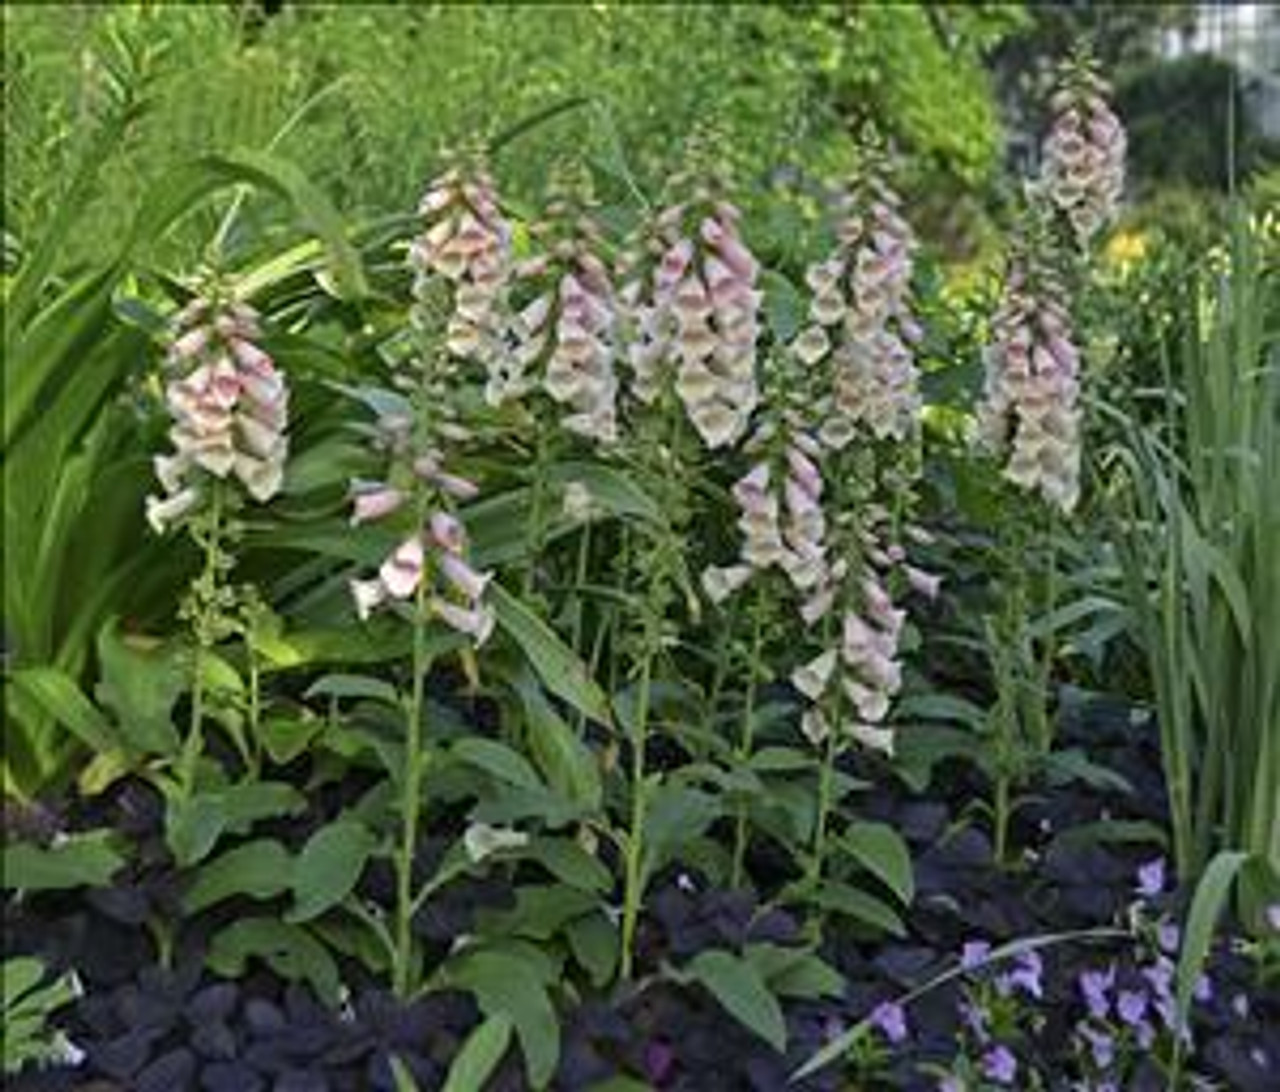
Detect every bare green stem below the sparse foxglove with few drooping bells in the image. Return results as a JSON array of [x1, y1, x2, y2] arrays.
[[392, 574, 429, 999]]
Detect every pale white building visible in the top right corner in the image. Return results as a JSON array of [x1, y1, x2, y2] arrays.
[[1162, 0, 1280, 141]]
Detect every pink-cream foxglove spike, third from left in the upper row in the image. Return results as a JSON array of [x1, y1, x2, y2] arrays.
[[507, 172, 618, 443]]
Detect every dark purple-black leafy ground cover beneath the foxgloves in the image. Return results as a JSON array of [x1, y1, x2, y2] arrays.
[[4, 705, 1280, 1092]]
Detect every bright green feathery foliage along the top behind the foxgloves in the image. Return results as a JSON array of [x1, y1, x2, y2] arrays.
[[4, 4, 1023, 270]]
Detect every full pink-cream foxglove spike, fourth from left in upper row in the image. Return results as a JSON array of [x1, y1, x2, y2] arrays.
[[625, 191, 763, 448]]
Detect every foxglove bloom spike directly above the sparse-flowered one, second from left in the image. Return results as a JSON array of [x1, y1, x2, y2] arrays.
[[410, 160, 512, 403]]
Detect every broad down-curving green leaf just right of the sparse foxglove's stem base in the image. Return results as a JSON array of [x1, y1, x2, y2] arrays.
[[449, 949, 561, 1088]]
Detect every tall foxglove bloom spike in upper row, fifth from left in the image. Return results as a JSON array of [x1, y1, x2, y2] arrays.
[[791, 172, 923, 451]]
